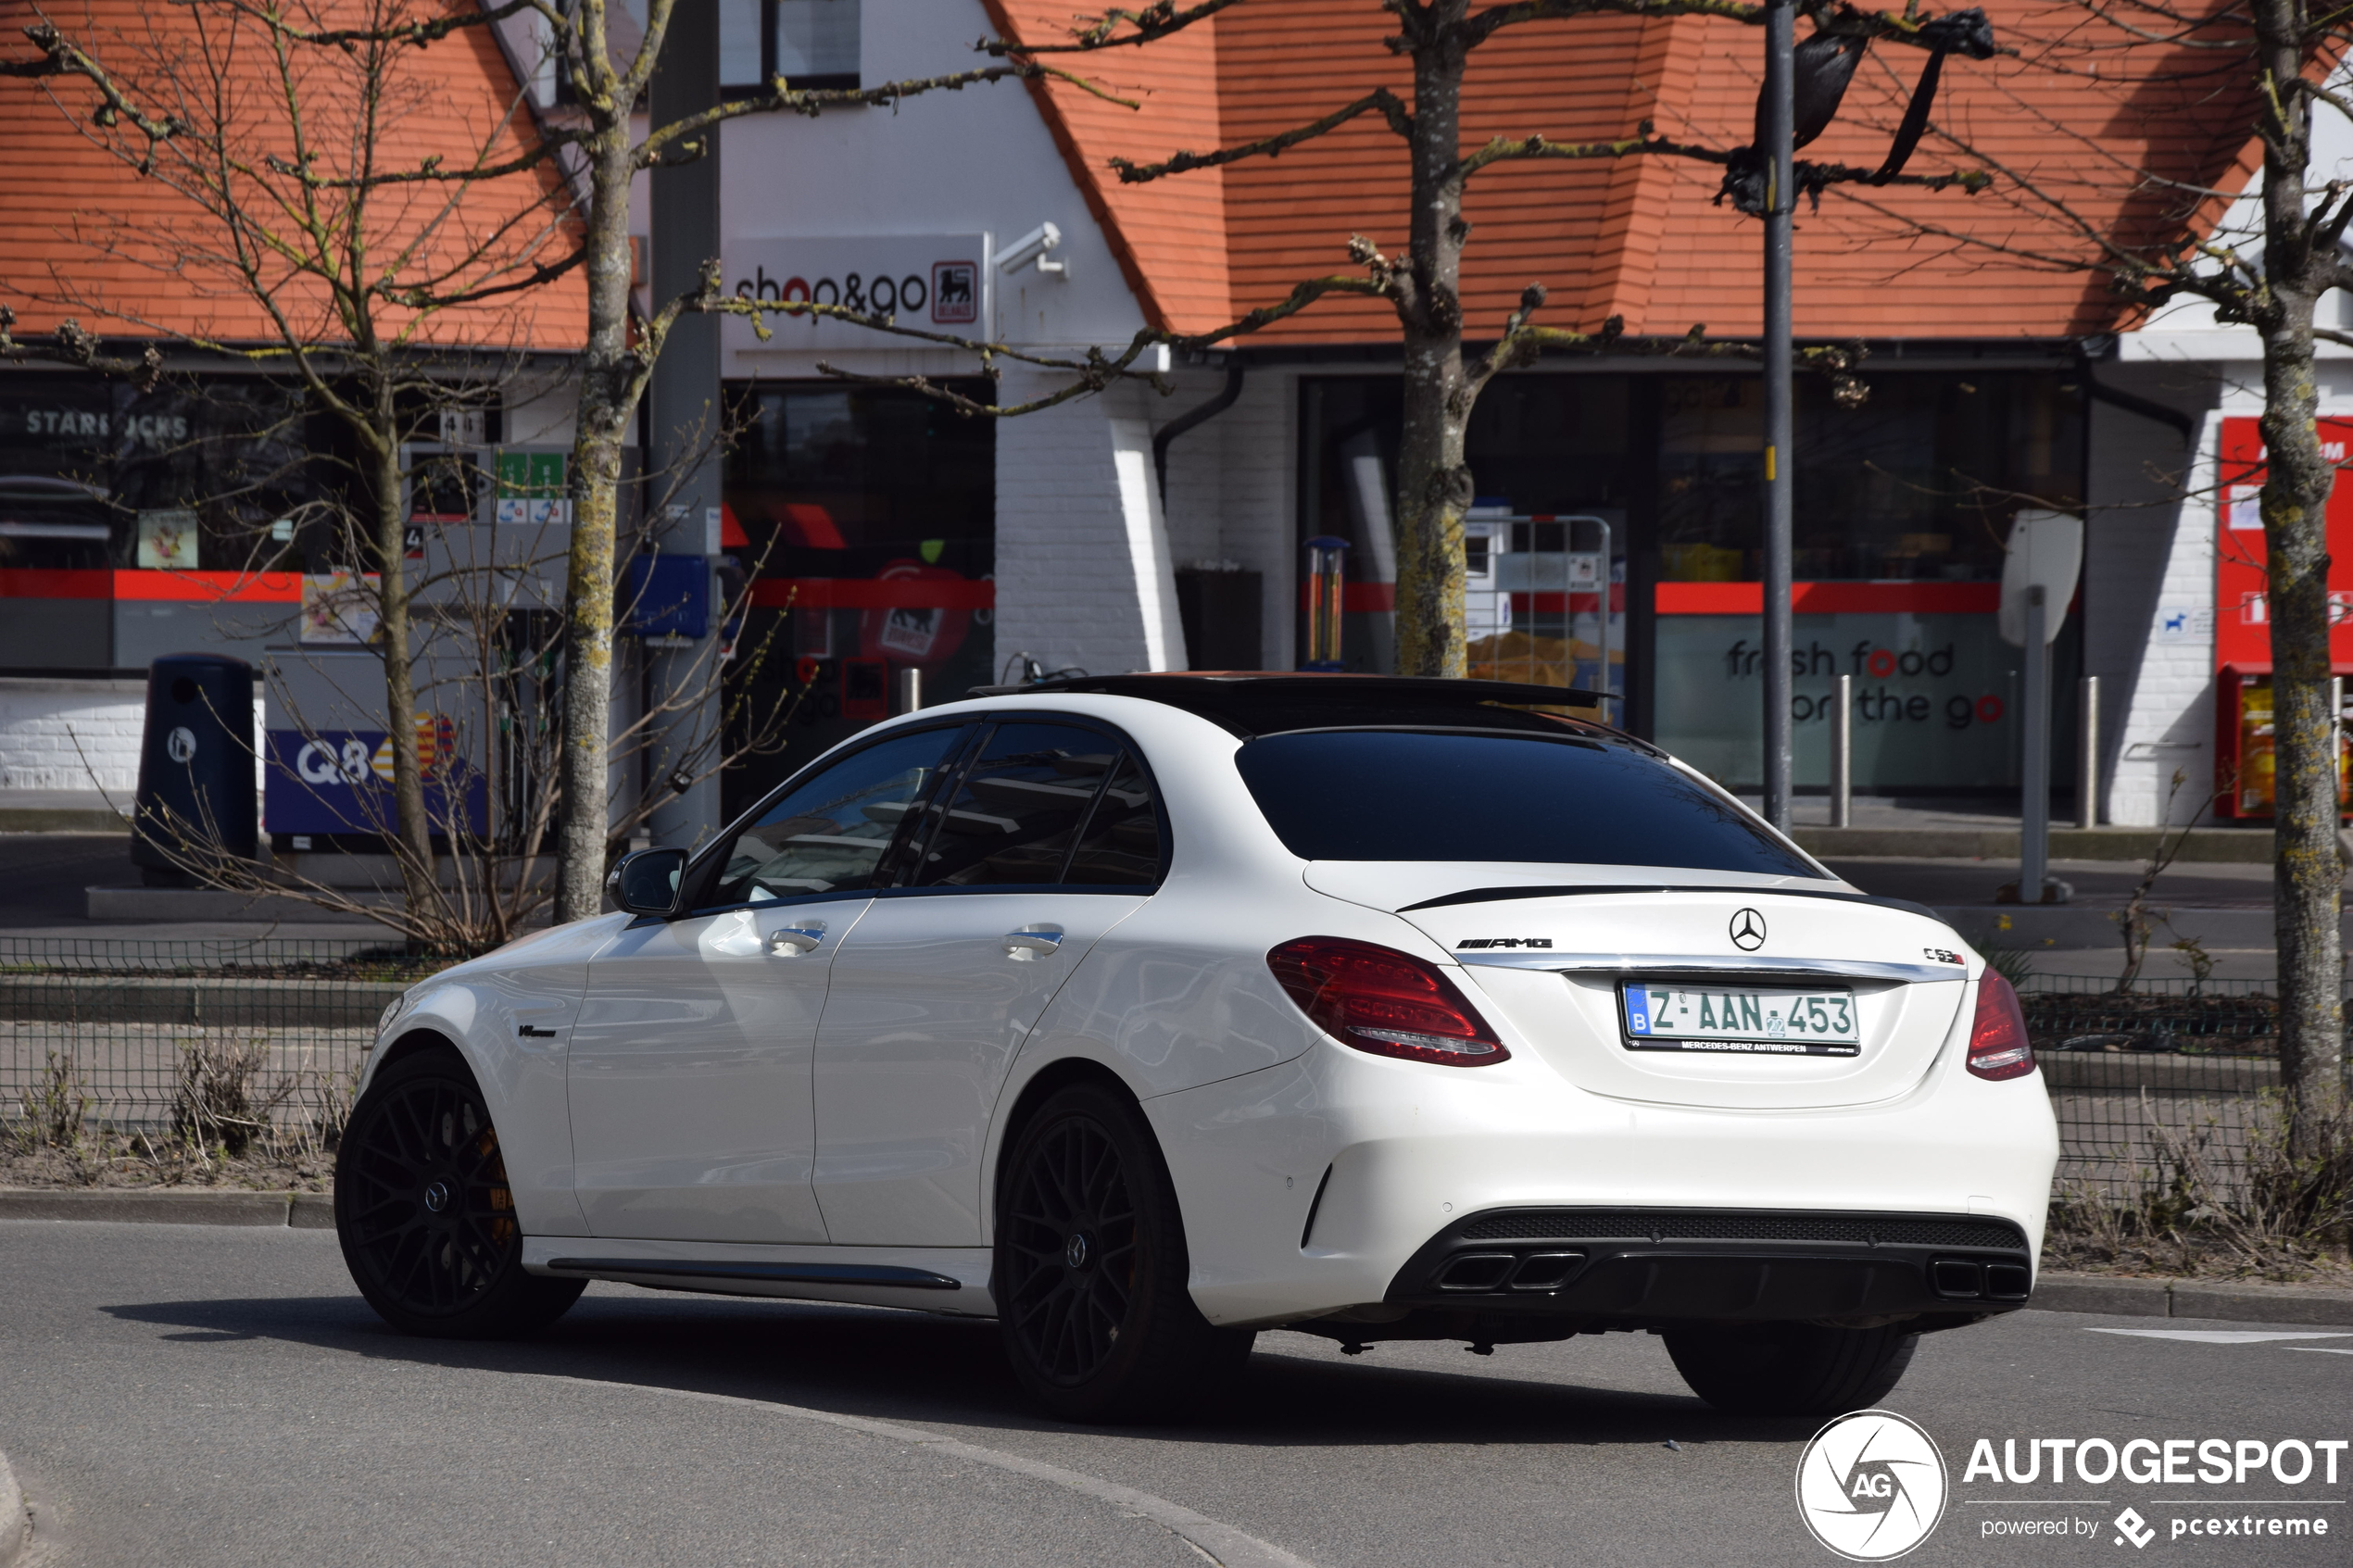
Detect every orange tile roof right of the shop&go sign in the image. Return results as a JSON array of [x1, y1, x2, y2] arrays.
[[990, 0, 2257, 344]]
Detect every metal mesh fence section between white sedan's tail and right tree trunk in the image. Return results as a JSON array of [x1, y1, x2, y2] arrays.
[[2019, 973, 2280, 1187]]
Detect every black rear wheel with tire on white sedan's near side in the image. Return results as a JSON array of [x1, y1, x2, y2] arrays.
[[993, 1084, 1256, 1423]]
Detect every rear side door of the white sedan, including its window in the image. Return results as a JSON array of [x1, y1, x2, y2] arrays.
[[816, 720, 1164, 1246]]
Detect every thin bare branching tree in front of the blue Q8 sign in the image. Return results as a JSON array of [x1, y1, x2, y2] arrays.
[[0, 0, 576, 926]]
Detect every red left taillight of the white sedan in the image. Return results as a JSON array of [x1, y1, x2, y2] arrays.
[[1266, 935, 1511, 1067]]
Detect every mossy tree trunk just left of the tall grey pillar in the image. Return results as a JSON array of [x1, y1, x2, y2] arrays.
[[555, 132, 645, 922]]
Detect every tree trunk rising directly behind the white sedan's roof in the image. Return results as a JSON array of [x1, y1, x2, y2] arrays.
[[1398, 0, 1476, 677]]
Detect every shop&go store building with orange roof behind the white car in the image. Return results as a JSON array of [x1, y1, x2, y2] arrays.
[[0, 0, 2324, 833]]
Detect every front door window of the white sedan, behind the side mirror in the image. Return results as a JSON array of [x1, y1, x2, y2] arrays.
[[701, 729, 972, 909]]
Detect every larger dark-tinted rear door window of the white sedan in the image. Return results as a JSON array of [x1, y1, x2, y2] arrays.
[[911, 724, 1120, 886]]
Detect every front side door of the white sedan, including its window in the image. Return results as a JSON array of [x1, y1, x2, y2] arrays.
[[567, 724, 969, 1241]]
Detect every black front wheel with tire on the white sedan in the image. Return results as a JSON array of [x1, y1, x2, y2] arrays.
[[334, 1048, 585, 1340]]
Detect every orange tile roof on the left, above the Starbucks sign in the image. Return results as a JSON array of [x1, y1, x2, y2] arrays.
[[0, 0, 585, 350]]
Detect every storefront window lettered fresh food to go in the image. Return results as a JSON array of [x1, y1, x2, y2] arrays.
[[1299, 370, 2084, 792]]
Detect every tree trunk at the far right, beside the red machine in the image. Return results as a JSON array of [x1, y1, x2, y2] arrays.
[[2254, 0, 2344, 1154]]
